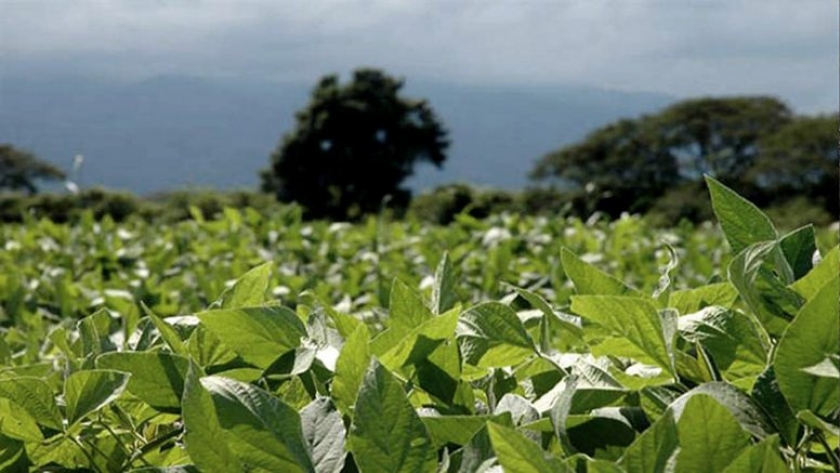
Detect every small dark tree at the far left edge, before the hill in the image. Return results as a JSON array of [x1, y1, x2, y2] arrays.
[[0, 143, 64, 195]]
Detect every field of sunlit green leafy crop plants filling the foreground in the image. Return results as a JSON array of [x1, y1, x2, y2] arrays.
[[0, 179, 840, 472]]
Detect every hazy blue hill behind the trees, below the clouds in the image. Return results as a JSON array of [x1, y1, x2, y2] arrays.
[[0, 77, 671, 194]]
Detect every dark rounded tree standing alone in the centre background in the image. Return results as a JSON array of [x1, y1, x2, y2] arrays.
[[262, 69, 449, 219]]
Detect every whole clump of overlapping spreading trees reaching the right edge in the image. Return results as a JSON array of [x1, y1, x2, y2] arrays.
[[531, 96, 838, 218]]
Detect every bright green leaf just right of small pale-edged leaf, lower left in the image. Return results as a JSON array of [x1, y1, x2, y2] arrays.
[[96, 352, 190, 413]]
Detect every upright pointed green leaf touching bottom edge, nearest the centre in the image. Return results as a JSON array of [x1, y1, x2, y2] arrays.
[[350, 359, 437, 473]]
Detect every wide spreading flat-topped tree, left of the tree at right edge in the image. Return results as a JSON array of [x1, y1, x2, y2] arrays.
[[531, 97, 793, 214]]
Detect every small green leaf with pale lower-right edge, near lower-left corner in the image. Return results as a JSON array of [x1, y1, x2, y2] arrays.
[[64, 370, 131, 425]]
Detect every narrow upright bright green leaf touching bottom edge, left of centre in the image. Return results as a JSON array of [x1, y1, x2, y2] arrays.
[[182, 363, 242, 473]]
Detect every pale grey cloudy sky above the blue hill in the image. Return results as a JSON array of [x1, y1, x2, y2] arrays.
[[0, 0, 840, 112]]
